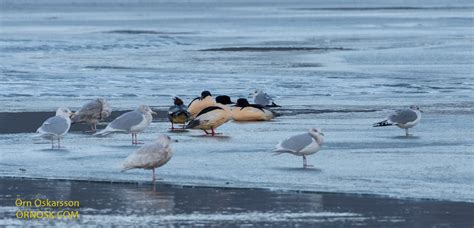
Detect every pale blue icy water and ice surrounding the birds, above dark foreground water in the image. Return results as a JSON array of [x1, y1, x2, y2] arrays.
[[0, 0, 474, 217]]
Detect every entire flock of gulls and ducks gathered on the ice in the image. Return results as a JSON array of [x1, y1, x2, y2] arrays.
[[37, 90, 422, 182]]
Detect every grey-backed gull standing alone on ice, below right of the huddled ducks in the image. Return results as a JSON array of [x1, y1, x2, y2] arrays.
[[273, 128, 324, 168]]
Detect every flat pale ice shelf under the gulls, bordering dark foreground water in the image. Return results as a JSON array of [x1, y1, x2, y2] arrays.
[[0, 109, 474, 202]]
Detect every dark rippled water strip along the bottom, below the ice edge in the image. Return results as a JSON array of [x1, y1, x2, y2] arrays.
[[0, 179, 474, 227]]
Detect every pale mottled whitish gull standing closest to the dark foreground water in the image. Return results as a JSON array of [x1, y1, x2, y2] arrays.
[[122, 135, 173, 183]]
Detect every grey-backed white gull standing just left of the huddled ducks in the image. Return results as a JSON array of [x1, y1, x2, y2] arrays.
[[94, 105, 156, 145]]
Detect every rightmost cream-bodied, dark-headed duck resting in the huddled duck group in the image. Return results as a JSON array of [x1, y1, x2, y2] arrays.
[[232, 98, 273, 121]]
